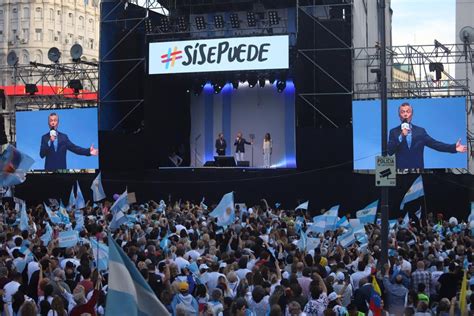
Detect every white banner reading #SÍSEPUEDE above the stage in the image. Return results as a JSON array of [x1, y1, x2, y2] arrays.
[[148, 35, 289, 75]]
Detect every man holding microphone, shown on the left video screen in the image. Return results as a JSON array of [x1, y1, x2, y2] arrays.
[[40, 113, 99, 171]]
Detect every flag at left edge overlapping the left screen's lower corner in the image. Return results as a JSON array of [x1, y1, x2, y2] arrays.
[[0, 145, 35, 187]]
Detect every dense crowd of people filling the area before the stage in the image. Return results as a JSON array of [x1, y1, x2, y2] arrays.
[[0, 194, 474, 316]]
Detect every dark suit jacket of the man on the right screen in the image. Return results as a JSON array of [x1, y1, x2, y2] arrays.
[[388, 125, 456, 169]]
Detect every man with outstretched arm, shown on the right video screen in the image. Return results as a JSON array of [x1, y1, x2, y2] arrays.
[[388, 102, 467, 169]]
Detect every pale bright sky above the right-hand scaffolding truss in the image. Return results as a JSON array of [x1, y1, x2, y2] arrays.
[[391, 0, 456, 46]]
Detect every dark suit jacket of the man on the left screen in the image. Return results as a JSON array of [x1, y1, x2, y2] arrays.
[[40, 132, 91, 171]]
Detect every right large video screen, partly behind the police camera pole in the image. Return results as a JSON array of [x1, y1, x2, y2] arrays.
[[352, 97, 467, 170]]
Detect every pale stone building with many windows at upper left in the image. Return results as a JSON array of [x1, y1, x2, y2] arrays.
[[0, 0, 100, 86]]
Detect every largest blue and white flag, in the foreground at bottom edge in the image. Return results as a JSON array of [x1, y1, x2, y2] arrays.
[[105, 235, 170, 316]]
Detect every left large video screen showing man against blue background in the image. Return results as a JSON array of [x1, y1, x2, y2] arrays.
[[16, 108, 99, 171]]
